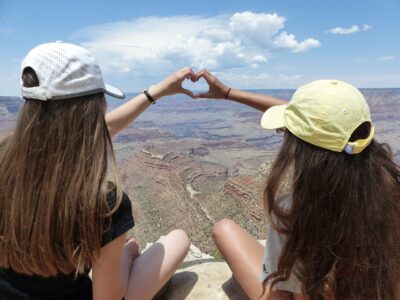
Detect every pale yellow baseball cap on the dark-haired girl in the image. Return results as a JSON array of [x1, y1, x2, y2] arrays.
[[261, 80, 375, 154]]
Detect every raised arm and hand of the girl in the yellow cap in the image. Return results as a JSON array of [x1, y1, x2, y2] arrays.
[[196, 70, 287, 111]]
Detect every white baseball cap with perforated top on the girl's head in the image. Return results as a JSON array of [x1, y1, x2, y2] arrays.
[[21, 42, 125, 101]]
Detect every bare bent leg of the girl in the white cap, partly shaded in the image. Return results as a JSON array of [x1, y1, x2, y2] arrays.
[[123, 229, 190, 300]]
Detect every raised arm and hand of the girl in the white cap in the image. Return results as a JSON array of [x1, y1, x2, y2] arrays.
[[106, 68, 195, 137]]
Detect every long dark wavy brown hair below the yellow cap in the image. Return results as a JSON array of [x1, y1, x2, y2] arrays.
[[264, 123, 400, 300]]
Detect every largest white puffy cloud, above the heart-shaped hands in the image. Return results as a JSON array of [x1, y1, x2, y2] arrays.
[[72, 12, 321, 72]]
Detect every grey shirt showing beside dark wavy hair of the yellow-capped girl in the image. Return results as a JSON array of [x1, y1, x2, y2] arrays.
[[260, 196, 301, 294]]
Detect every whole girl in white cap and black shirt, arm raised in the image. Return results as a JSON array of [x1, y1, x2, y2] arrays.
[[0, 43, 194, 300]]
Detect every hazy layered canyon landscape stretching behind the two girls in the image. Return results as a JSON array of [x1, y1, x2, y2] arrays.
[[0, 89, 400, 253]]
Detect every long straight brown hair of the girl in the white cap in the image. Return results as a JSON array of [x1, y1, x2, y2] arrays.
[[0, 68, 121, 276]]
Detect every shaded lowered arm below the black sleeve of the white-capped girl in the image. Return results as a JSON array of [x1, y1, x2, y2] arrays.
[[92, 233, 127, 300]]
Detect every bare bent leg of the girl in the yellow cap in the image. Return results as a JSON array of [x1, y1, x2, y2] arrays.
[[213, 219, 292, 300]]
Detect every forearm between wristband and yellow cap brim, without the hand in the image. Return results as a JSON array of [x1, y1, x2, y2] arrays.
[[228, 89, 287, 112]]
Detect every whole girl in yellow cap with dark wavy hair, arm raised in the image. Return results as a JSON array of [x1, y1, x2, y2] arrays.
[[196, 70, 400, 300]]
